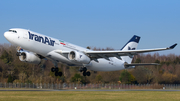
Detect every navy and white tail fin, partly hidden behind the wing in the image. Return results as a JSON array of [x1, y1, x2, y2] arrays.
[[121, 35, 140, 64]]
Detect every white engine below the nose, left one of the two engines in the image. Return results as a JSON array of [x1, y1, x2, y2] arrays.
[[19, 52, 41, 64]]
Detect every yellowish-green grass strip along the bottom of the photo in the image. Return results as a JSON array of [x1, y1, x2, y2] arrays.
[[0, 91, 180, 101]]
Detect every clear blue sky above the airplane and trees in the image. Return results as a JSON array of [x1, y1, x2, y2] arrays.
[[0, 0, 180, 55]]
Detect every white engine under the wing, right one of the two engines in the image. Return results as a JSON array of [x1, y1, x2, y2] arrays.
[[68, 51, 91, 64]]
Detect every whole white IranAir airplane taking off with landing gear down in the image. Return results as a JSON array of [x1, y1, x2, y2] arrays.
[[4, 28, 177, 76]]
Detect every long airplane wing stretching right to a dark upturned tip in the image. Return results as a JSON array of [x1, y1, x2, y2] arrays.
[[84, 44, 177, 60]]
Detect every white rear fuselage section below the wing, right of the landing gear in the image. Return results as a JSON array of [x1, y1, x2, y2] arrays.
[[87, 58, 124, 71]]
